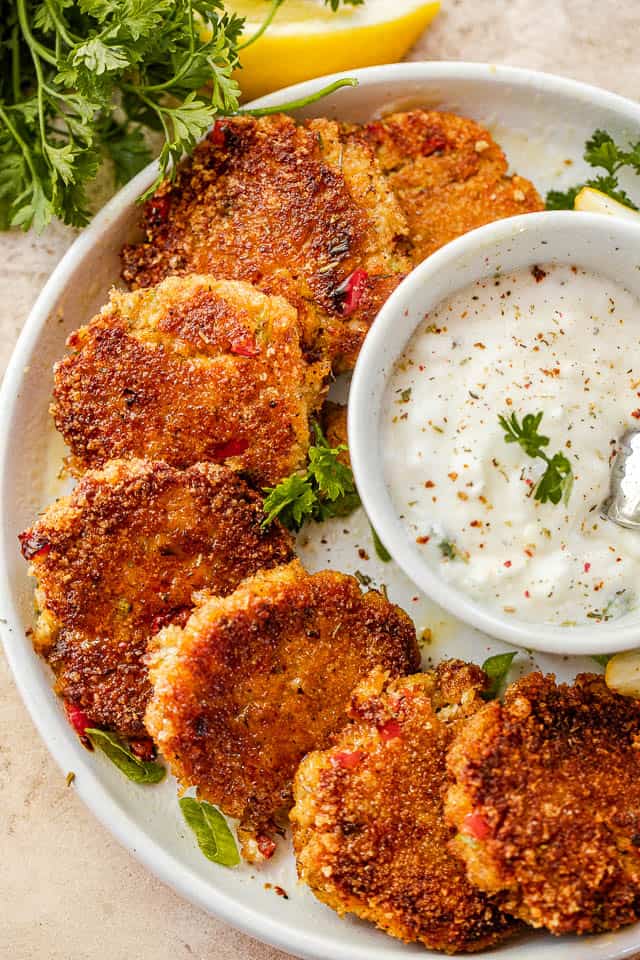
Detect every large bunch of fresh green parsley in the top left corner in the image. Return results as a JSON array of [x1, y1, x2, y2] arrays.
[[0, 0, 361, 231]]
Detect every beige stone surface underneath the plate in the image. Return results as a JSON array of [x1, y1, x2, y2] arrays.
[[0, 0, 640, 960]]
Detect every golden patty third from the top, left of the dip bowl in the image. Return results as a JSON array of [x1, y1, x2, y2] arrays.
[[52, 275, 329, 486]]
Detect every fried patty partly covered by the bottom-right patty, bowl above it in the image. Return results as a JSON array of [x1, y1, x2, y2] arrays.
[[290, 660, 517, 953]]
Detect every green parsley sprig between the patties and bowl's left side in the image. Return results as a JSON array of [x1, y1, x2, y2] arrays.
[[262, 423, 360, 530]]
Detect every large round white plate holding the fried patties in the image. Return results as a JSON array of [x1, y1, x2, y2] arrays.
[[0, 63, 640, 960]]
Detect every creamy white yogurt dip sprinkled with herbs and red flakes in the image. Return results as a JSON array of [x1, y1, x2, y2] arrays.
[[382, 265, 640, 625]]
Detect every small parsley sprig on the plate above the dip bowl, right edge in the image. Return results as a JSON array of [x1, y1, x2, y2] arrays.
[[547, 130, 640, 210]]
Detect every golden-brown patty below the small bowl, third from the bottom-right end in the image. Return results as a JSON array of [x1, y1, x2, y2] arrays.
[[146, 560, 419, 860]]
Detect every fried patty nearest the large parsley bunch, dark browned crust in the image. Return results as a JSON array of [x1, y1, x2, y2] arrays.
[[122, 114, 411, 369]]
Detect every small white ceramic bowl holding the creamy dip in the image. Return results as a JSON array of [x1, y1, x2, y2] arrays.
[[349, 211, 640, 654]]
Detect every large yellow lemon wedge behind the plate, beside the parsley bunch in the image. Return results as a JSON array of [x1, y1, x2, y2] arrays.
[[227, 0, 440, 99]]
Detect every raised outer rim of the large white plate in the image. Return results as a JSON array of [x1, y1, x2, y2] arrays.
[[0, 61, 640, 960]]
